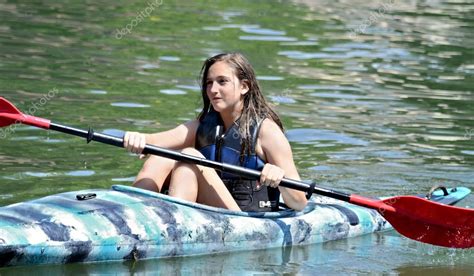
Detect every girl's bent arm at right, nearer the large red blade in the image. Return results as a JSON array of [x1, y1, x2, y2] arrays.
[[258, 119, 307, 210]]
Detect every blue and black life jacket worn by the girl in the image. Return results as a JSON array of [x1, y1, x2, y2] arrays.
[[195, 110, 280, 212]]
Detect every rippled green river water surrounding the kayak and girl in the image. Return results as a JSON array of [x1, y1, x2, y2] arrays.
[[0, 0, 474, 275]]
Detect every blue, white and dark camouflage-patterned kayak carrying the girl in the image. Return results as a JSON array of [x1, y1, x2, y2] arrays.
[[0, 185, 470, 266]]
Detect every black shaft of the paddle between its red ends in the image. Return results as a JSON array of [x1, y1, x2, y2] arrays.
[[49, 122, 350, 202]]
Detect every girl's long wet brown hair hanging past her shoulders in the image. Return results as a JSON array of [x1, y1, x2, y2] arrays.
[[198, 53, 283, 156]]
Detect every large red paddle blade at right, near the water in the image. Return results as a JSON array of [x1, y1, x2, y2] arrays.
[[379, 196, 474, 248]]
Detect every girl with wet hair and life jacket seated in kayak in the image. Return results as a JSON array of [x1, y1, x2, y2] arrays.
[[124, 53, 307, 211]]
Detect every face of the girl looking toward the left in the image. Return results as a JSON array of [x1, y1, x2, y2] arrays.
[[206, 61, 249, 114]]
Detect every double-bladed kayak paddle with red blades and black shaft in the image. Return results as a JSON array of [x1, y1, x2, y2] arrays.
[[0, 97, 474, 248]]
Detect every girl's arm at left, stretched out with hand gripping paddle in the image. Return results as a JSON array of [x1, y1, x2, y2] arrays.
[[124, 120, 199, 154]]
